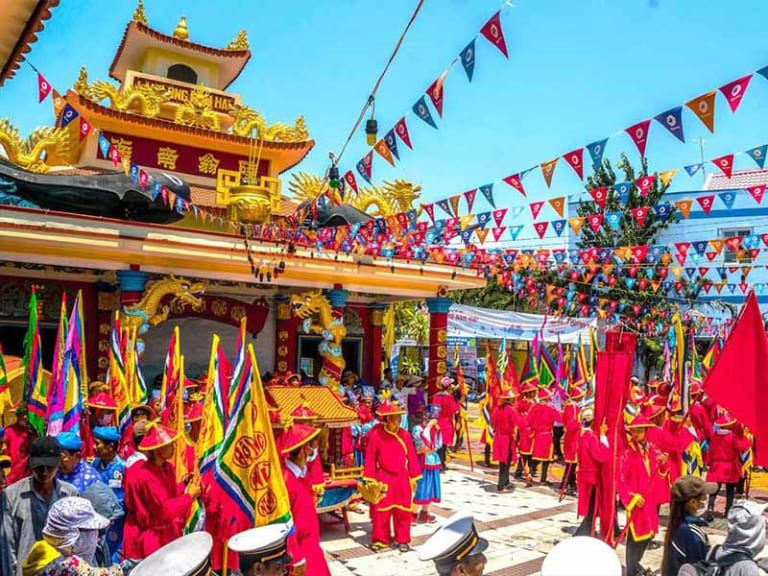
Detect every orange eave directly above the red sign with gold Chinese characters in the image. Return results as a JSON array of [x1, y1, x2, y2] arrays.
[[66, 90, 315, 173]]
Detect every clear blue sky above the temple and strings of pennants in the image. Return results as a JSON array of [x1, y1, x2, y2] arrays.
[[0, 0, 768, 218]]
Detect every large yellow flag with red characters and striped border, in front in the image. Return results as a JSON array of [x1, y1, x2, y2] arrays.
[[214, 344, 291, 526]]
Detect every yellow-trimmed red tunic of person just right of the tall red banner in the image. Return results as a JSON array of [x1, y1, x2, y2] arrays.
[[618, 442, 659, 540]]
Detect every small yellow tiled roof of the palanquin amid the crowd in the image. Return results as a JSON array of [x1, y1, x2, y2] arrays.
[[269, 386, 357, 428]]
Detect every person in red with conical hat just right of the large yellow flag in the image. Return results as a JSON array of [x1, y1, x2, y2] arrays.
[[279, 422, 331, 576]]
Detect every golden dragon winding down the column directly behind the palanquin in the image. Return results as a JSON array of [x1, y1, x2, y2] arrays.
[[291, 290, 347, 392]]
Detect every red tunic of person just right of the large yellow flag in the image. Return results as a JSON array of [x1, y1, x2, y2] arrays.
[[283, 466, 331, 576]]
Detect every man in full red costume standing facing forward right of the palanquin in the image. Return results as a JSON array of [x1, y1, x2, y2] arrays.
[[363, 393, 421, 552]]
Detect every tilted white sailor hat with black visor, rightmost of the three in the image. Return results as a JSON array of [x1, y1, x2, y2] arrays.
[[419, 512, 488, 566]]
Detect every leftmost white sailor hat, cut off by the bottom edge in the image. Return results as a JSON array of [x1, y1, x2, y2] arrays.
[[131, 532, 213, 576]]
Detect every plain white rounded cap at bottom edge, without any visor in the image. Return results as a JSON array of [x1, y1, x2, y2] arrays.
[[541, 536, 621, 576]]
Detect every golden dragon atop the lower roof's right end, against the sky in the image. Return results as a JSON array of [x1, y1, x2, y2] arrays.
[[288, 172, 421, 217]]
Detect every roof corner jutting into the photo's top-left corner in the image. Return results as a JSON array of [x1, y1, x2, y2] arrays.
[[0, 0, 59, 86]]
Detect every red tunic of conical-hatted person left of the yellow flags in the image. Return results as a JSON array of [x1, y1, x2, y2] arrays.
[[123, 460, 192, 560]]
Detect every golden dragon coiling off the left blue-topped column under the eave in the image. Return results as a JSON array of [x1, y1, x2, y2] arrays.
[[120, 274, 206, 335]]
